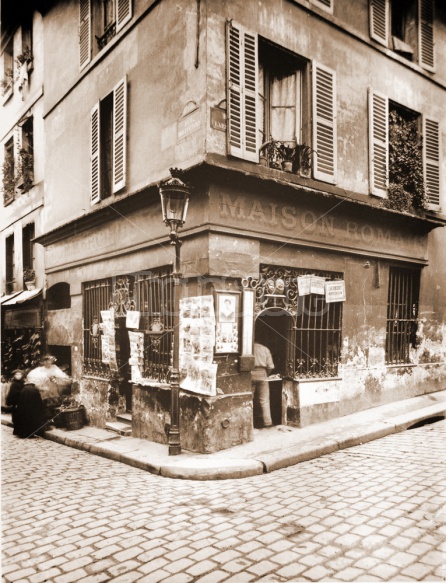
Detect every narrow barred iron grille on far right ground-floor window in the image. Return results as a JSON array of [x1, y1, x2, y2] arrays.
[[386, 267, 420, 364]]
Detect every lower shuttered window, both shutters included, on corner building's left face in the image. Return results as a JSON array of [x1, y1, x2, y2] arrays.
[[90, 78, 127, 204]]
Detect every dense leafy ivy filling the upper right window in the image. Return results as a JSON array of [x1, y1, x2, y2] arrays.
[[384, 110, 427, 212]]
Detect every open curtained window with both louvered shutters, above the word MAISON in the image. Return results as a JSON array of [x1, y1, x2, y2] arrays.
[[227, 21, 336, 183]]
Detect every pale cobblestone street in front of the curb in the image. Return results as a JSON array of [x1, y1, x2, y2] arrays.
[[2, 421, 446, 583]]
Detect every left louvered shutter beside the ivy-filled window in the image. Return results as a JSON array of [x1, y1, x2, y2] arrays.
[[369, 91, 389, 198]]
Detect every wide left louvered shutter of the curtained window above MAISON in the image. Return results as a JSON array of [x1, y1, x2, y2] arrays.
[[227, 22, 259, 162]]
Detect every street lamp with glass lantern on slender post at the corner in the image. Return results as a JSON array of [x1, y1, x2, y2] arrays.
[[159, 168, 191, 455]]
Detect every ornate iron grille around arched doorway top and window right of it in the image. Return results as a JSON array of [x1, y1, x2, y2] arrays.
[[246, 265, 342, 378]]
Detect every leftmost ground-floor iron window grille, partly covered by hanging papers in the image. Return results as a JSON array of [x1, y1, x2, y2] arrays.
[[84, 279, 112, 376]]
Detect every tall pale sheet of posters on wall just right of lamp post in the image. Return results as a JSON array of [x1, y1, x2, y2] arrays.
[[180, 296, 217, 396]]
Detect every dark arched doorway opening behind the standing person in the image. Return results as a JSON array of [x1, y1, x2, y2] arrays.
[[254, 308, 294, 427]]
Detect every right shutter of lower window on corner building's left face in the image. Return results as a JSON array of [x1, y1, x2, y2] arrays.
[[113, 78, 127, 193]]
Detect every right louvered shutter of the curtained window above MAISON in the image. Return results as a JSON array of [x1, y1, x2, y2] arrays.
[[313, 63, 337, 184]]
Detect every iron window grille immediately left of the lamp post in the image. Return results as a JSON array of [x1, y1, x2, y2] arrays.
[[136, 267, 173, 382]]
